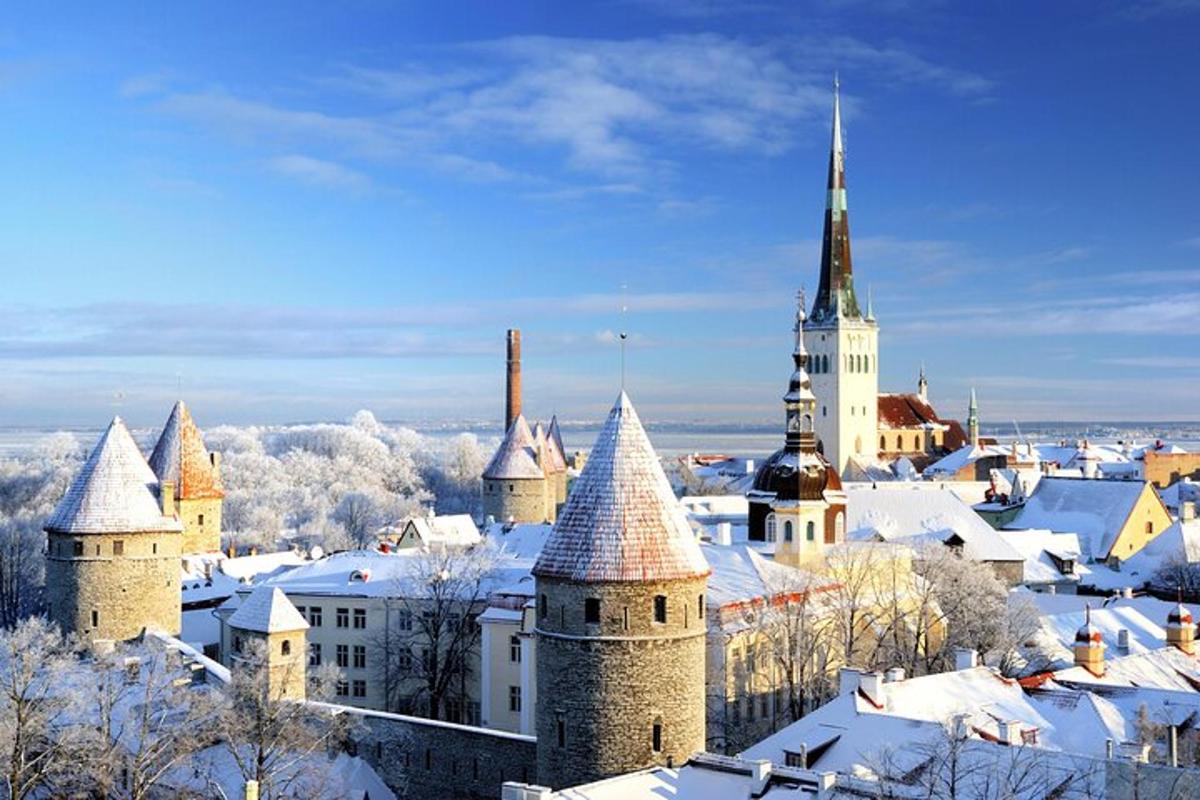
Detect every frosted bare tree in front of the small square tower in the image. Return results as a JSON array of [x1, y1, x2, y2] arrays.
[[217, 642, 353, 800]]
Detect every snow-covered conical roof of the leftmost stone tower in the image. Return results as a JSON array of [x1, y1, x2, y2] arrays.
[[46, 416, 182, 534]]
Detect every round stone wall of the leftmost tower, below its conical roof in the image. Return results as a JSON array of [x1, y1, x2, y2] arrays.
[[46, 531, 182, 640]]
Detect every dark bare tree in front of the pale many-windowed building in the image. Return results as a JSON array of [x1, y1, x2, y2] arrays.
[[372, 545, 499, 721]]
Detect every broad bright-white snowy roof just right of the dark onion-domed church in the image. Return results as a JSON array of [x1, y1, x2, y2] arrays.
[[846, 482, 1024, 561]]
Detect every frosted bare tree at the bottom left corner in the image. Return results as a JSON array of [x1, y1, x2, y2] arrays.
[[0, 616, 80, 800]]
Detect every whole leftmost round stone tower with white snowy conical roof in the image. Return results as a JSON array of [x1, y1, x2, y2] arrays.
[[46, 417, 182, 640]]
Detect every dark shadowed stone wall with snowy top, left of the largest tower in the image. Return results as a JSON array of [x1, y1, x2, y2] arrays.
[[342, 706, 538, 800]]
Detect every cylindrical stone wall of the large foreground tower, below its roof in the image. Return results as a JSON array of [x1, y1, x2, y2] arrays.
[[536, 578, 706, 787]]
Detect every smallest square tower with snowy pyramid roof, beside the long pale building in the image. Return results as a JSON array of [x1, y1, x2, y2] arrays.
[[224, 585, 308, 700]]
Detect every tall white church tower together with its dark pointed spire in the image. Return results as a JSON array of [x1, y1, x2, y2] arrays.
[[804, 76, 880, 474]]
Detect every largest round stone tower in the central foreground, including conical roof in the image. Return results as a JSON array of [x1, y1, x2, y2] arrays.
[[533, 392, 709, 787]]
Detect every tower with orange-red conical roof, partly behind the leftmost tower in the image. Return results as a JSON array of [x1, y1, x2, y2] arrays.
[[150, 401, 224, 555]]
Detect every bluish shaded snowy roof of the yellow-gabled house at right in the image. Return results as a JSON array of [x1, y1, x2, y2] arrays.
[[1004, 476, 1146, 560]]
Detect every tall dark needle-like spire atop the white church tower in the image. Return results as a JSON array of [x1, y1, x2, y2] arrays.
[[812, 77, 863, 323]]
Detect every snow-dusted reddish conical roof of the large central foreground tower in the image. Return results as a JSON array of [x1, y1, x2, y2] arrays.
[[533, 392, 710, 582]]
